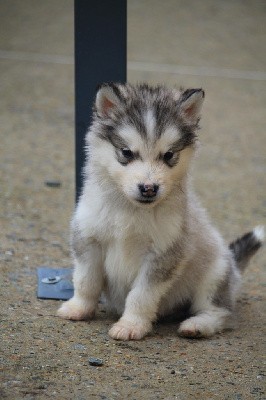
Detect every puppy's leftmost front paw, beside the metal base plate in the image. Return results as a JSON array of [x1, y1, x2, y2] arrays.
[[57, 297, 95, 321]]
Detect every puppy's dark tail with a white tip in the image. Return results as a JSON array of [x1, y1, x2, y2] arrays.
[[229, 226, 264, 272]]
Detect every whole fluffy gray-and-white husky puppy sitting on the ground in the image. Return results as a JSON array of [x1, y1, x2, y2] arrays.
[[58, 83, 263, 340]]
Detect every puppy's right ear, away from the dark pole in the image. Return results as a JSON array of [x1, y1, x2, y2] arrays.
[[179, 89, 205, 124]]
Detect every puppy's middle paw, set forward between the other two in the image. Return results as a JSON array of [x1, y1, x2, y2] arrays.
[[109, 318, 151, 340]]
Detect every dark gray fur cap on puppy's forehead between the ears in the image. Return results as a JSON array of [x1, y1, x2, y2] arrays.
[[94, 84, 198, 147]]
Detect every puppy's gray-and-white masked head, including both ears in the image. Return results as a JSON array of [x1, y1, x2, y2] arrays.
[[87, 84, 204, 207]]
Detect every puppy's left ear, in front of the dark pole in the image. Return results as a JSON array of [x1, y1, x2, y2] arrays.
[[95, 84, 120, 117]]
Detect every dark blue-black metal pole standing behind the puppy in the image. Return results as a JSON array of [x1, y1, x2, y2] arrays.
[[75, 0, 127, 200]]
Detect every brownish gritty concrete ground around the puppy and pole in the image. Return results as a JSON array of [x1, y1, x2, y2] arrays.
[[0, 0, 266, 400]]
